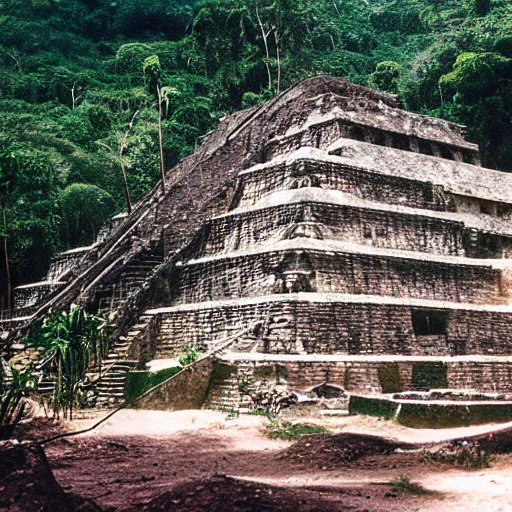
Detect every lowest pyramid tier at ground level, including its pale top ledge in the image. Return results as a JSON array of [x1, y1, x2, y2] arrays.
[[206, 353, 512, 407]]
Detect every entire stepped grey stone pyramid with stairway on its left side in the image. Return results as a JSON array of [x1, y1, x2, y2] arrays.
[[0, 77, 512, 418]]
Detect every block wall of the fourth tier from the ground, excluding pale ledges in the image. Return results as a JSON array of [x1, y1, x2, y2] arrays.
[[194, 203, 464, 257]]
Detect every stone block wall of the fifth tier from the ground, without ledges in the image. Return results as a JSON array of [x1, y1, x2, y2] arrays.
[[233, 160, 455, 211]]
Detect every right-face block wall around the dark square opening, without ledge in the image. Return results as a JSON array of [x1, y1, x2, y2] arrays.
[[295, 303, 512, 356]]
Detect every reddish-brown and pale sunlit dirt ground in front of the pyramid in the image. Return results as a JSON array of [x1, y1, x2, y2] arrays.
[[11, 410, 504, 512]]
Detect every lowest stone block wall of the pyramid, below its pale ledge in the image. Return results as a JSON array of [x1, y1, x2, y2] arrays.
[[206, 360, 512, 408]]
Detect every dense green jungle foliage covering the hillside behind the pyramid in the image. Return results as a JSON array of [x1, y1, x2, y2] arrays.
[[0, 0, 512, 304]]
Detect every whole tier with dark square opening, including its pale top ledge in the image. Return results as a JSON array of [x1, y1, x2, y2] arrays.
[[146, 293, 512, 358]]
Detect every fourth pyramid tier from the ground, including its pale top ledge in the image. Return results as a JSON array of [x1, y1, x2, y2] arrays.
[[197, 193, 472, 258]]
